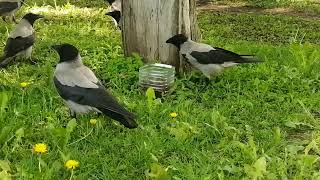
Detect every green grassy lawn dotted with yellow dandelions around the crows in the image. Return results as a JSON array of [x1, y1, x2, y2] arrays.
[[0, 0, 320, 180]]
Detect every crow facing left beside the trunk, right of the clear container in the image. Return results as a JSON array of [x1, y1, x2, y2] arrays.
[[166, 34, 261, 79]]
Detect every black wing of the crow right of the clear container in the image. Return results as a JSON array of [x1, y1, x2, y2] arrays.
[[190, 47, 248, 64]]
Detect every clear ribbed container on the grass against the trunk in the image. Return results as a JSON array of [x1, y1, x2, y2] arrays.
[[139, 63, 175, 93]]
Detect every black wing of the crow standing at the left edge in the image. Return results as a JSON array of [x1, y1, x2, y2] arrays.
[[4, 34, 35, 58]]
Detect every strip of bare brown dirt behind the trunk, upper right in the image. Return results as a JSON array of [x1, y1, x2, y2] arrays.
[[198, 3, 320, 19]]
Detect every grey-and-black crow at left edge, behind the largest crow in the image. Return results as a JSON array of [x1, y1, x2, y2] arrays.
[[0, 13, 43, 67]]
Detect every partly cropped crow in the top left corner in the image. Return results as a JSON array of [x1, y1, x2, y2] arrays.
[[0, 0, 24, 22]]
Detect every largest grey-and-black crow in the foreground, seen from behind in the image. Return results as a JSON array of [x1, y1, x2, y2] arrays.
[[52, 44, 138, 129]]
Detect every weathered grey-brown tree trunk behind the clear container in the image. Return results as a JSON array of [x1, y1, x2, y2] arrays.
[[122, 0, 200, 70]]
